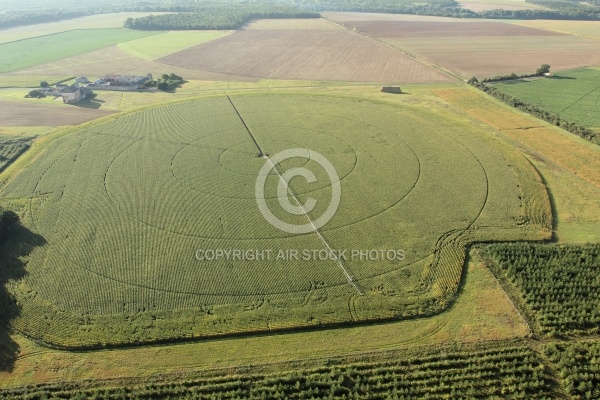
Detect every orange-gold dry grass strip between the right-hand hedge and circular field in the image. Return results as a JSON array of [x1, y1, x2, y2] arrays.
[[434, 88, 600, 188]]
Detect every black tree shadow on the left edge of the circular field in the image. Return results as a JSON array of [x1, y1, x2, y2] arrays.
[[0, 217, 46, 372]]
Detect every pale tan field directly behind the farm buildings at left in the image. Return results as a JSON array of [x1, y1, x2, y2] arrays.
[[0, 46, 258, 82]]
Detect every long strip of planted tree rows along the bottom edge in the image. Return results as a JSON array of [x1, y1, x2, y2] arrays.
[[0, 345, 553, 400]]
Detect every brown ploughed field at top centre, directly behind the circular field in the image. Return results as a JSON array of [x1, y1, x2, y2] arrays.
[[158, 30, 451, 82]]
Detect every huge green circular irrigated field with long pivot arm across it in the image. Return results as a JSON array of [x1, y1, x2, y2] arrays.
[[0, 94, 551, 347]]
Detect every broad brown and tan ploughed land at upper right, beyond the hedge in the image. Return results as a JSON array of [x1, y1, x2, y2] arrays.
[[324, 13, 600, 79]]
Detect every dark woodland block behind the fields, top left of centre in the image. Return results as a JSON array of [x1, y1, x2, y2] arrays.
[[125, 3, 320, 30]]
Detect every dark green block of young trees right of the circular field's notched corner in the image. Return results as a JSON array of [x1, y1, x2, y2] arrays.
[[483, 243, 600, 336]]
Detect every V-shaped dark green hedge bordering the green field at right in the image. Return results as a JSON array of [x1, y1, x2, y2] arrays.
[[467, 75, 600, 145]]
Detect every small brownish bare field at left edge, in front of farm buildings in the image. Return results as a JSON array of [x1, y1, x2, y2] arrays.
[[0, 99, 112, 126]]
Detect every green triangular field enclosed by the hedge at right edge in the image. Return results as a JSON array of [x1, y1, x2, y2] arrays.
[[494, 68, 600, 129]]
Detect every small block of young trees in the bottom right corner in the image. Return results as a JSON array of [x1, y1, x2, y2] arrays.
[[544, 341, 600, 400]]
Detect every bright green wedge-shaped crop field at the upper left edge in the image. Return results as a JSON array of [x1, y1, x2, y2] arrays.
[[0, 29, 160, 73]]
